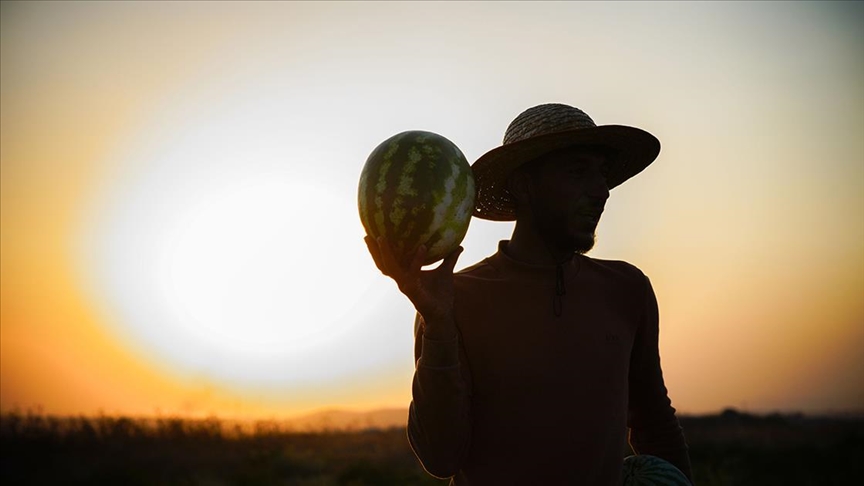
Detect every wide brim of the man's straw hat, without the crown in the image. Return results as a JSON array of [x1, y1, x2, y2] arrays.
[[471, 125, 660, 221]]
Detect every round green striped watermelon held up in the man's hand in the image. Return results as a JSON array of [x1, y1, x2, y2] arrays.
[[358, 130, 475, 265]]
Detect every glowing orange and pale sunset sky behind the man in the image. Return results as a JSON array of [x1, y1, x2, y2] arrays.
[[0, 2, 864, 416]]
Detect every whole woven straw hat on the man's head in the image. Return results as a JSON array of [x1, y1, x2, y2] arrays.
[[471, 103, 660, 221]]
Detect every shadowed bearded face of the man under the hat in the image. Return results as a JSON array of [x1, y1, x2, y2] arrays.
[[530, 149, 609, 253]]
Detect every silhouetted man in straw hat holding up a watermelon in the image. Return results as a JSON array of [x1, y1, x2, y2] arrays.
[[367, 104, 690, 486]]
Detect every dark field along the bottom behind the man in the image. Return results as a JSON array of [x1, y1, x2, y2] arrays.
[[0, 410, 864, 486]]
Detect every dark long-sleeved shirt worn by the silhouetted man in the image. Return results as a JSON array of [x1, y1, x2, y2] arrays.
[[408, 241, 690, 486]]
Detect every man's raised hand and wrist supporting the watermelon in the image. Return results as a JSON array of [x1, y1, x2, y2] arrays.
[[365, 236, 463, 339]]
